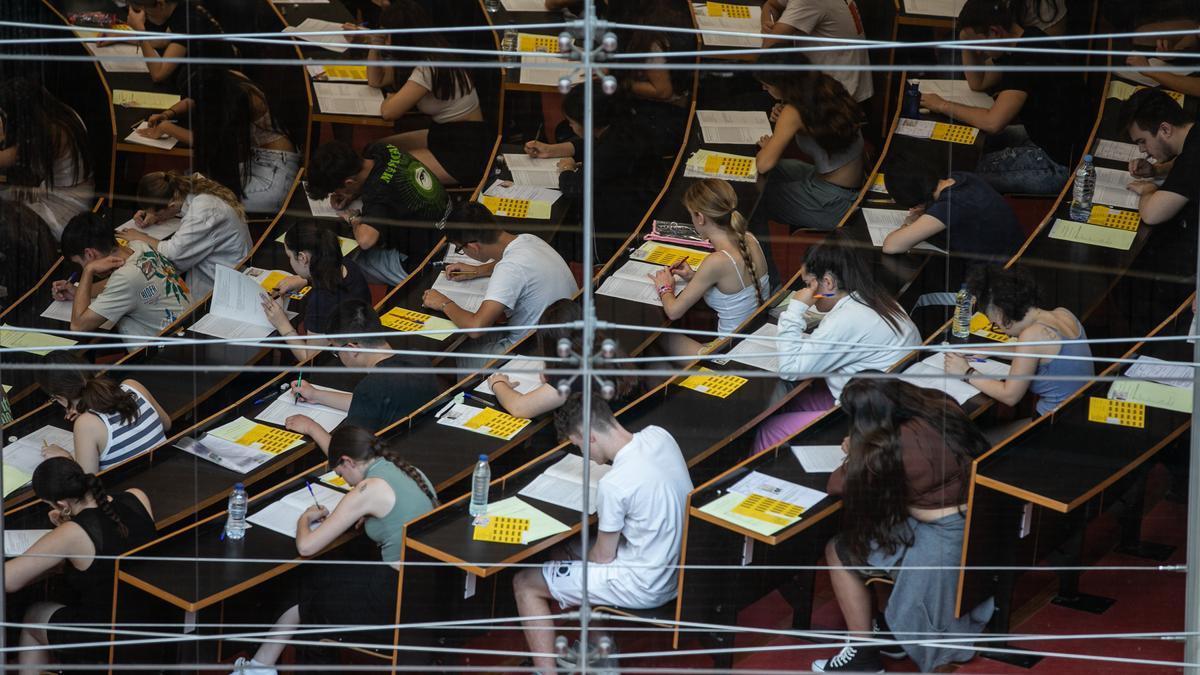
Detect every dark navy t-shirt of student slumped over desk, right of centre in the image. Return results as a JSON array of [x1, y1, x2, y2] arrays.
[[925, 171, 1025, 262]]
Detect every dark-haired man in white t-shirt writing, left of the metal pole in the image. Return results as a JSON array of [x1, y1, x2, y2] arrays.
[[421, 202, 578, 353]]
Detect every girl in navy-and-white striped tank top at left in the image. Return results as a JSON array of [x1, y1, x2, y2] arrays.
[[37, 352, 170, 473]]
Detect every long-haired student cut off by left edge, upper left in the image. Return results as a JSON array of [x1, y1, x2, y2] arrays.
[[0, 77, 96, 239]]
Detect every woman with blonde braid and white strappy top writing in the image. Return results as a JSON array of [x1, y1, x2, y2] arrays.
[[649, 178, 770, 356]]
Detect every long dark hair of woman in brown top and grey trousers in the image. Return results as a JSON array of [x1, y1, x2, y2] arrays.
[[840, 377, 989, 562]]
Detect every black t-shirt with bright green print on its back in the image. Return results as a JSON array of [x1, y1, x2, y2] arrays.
[[361, 143, 446, 258]]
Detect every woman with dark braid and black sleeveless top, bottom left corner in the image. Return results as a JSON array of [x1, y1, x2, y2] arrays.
[[4, 458, 155, 673]]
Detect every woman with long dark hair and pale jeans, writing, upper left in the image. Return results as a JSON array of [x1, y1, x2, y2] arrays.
[[138, 66, 300, 215]]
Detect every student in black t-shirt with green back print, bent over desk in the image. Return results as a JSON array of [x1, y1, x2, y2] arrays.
[[308, 141, 446, 286]]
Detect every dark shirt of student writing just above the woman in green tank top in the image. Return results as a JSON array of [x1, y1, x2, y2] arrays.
[[346, 354, 442, 431]]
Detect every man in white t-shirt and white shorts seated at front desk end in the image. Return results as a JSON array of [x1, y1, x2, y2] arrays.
[[512, 394, 691, 674]]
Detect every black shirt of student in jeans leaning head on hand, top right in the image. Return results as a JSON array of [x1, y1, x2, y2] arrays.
[[996, 28, 1091, 167]]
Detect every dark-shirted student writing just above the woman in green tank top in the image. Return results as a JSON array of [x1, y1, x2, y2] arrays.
[[283, 300, 442, 453]]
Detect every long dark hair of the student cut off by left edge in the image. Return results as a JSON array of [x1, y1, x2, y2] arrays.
[[0, 77, 91, 187]]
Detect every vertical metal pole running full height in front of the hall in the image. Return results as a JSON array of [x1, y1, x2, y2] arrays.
[[580, 0, 595, 675]]
